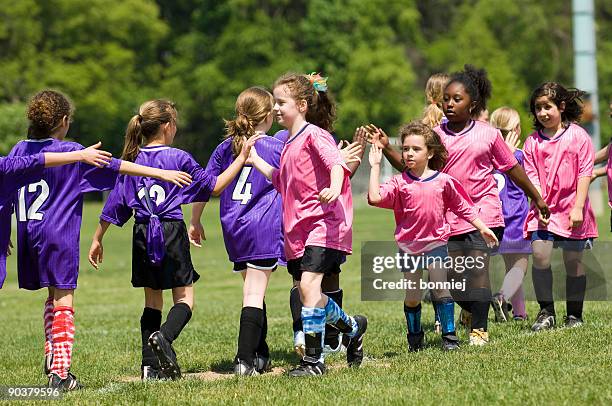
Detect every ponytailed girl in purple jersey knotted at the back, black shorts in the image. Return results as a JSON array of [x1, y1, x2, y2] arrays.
[[89, 100, 260, 380]]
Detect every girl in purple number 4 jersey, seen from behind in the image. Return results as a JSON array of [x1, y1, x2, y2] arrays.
[[189, 87, 285, 376]]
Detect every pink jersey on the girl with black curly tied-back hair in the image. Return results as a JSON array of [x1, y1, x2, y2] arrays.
[[434, 121, 518, 236]]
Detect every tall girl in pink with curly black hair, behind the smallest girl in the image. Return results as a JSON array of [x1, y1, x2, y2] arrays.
[[370, 65, 548, 345]]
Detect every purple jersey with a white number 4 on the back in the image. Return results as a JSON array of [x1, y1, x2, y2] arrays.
[[206, 137, 285, 262]]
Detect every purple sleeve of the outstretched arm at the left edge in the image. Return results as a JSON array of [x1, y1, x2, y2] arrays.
[[0, 153, 45, 194]]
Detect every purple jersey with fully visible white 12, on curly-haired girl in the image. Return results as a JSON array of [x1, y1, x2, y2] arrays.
[[10, 138, 121, 290]]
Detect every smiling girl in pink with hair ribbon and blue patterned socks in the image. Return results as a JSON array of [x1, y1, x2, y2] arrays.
[[247, 74, 367, 376]]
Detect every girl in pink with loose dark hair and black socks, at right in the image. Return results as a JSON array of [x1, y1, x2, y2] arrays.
[[524, 82, 598, 331]]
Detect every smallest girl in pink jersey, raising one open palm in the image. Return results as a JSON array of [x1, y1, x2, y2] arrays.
[[368, 122, 498, 351]]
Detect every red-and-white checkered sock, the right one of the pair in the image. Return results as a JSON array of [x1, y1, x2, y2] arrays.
[[51, 306, 74, 379]]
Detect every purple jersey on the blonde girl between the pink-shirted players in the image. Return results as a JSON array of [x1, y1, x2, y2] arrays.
[[493, 149, 531, 254]]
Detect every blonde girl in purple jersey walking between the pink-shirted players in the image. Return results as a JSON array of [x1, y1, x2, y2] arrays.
[[491, 107, 531, 322]]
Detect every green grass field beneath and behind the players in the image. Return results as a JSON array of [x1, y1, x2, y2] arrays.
[[0, 203, 612, 404]]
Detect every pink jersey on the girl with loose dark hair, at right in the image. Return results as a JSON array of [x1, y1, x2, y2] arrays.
[[523, 124, 597, 239]]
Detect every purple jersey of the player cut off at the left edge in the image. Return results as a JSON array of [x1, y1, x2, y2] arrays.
[[0, 154, 45, 289]]
